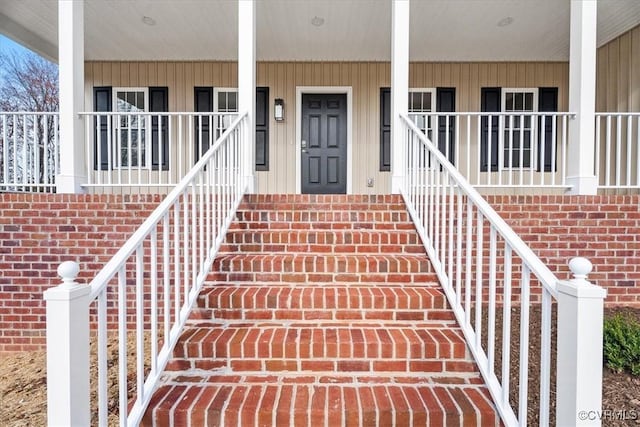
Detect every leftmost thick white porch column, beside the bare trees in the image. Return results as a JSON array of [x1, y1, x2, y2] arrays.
[[56, 0, 87, 193]]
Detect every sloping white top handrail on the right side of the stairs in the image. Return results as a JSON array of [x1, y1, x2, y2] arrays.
[[401, 113, 558, 296]]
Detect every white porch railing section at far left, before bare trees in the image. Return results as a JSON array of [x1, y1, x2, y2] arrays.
[[0, 112, 60, 192]]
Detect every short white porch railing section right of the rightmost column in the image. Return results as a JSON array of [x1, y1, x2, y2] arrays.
[[595, 113, 640, 189]]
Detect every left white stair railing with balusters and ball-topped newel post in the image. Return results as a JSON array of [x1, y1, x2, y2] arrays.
[[45, 114, 250, 426]]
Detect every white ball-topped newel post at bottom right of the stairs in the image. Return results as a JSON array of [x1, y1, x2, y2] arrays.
[[556, 258, 607, 426]]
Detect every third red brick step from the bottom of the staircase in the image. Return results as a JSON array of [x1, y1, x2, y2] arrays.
[[193, 283, 453, 320]]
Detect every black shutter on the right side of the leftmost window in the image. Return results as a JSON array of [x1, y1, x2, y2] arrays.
[[149, 87, 169, 170]]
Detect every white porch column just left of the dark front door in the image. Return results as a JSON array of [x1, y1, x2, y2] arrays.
[[238, 0, 256, 193]]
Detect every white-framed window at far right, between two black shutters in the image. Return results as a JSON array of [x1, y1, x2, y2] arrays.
[[502, 89, 538, 169]]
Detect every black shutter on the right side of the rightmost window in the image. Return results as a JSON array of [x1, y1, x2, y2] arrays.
[[538, 87, 558, 172]]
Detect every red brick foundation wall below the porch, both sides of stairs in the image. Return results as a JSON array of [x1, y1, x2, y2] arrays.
[[0, 194, 640, 353]]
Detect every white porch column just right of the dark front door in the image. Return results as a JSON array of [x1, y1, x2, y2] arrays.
[[391, 0, 410, 194]]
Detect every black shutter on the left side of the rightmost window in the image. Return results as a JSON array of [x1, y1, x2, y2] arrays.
[[480, 87, 502, 172]]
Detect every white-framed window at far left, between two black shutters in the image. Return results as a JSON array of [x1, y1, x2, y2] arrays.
[[113, 88, 149, 167]]
